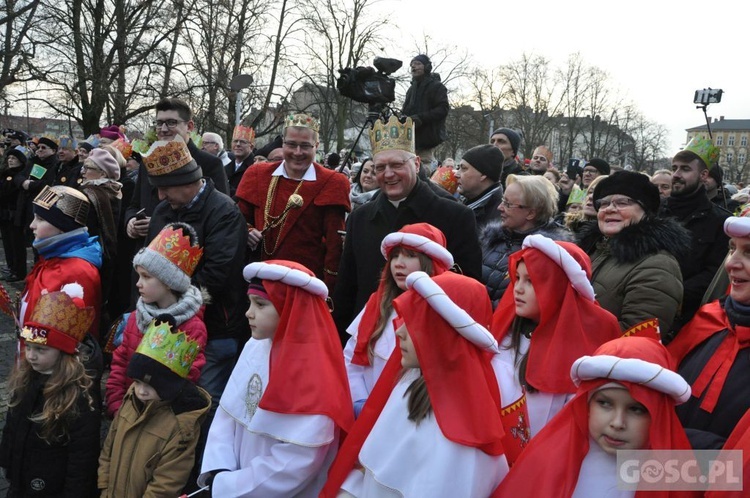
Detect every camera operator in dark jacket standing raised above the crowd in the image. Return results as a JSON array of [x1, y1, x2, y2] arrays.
[[401, 54, 450, 173]]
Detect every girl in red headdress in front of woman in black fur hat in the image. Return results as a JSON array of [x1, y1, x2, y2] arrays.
[[491, 234, 621, 437]]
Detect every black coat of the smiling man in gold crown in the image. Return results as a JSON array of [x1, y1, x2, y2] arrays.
[[333, 181, 482, 338]]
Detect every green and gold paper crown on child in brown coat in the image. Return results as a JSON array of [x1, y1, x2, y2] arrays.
[[135, 320, 201, 379]]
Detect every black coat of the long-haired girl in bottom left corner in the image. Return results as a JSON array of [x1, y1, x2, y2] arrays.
[[0, 373, 101, 498]]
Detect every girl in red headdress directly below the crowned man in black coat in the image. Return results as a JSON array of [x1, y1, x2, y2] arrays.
[[344, 223, 453, 416]]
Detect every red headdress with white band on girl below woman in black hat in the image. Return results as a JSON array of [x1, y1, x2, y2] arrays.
[[491, 234, 621, 394]]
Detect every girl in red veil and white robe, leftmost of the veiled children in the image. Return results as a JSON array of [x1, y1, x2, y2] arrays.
[[198, 260, 354, 498]]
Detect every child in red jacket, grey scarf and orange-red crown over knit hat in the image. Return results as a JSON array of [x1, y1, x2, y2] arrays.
[[106, 223, 207, 417]]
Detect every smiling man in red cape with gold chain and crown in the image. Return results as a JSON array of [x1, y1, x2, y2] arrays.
[[235, 113, 351, 290]]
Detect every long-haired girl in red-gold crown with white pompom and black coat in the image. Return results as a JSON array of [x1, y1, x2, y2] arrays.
[[0, 285, 101, 498]]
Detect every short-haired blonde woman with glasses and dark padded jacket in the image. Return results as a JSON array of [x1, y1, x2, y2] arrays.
[[479, 175, 573, 307]]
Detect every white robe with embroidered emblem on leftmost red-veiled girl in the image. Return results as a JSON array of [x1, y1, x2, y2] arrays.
[[198, 339, 339, 498]]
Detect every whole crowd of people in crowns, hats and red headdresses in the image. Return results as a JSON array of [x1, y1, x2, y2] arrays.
[[0, 61, 750, 498]]
